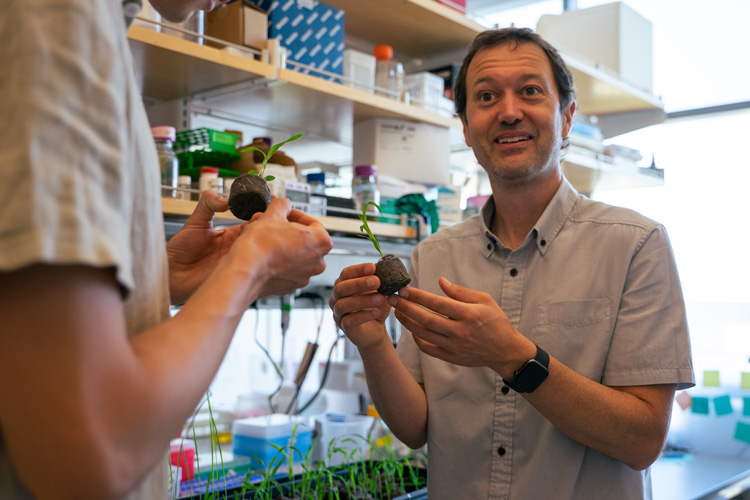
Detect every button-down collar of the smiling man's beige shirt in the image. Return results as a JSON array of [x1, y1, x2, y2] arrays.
[[480, 177, 579, 256]]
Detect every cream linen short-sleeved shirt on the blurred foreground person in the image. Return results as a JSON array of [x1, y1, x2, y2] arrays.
[[0, 0, 169, 500]]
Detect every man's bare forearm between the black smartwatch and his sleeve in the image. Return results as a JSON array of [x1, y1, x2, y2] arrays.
[[524, 358, 674, 470]]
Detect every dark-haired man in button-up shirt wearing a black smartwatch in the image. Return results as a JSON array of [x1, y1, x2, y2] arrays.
[[330, 28, 694, 500]]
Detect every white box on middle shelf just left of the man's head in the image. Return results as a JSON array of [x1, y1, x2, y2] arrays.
[[352, 118, 450, 185]]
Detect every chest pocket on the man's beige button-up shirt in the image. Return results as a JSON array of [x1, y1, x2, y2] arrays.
[[532, 298, 614, 381]]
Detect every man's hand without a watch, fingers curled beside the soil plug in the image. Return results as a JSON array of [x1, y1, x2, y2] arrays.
[[328, 263, 391, 348]]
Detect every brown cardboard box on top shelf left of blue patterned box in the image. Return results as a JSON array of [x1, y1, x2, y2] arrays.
[[205, 2, 268, 50]]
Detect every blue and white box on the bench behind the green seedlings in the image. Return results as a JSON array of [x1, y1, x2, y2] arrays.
[[232, 413, 312, 469]]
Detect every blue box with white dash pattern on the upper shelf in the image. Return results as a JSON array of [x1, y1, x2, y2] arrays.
[[249, 0, 344, 81]]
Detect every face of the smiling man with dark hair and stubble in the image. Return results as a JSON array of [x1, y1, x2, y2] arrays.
[[463, 43, 575, 185]]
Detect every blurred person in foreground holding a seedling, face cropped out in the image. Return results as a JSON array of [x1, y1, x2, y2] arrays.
[[0, 0, 332, 500]]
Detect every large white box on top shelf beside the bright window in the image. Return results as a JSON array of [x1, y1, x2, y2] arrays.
[[536, 2, 654, 93]]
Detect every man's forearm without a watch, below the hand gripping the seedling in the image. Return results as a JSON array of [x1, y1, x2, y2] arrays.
[[359, 335, 427, 449]]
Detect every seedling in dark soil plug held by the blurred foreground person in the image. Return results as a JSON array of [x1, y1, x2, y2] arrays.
[[229, 134, 302, 220]]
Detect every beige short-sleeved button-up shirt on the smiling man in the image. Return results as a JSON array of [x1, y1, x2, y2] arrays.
[[398, 180, 694, 500]]
